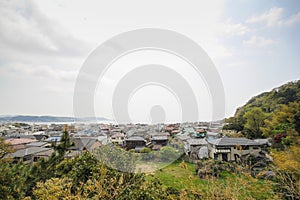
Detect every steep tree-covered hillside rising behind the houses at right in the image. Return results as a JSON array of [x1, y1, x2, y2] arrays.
[[223, 80, 300, 141]]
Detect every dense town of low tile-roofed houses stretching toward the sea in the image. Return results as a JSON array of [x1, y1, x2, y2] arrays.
[[0, 122, 269, 163]]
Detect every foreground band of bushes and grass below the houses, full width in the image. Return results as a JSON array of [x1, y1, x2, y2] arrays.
[[0, 130, 299, 199]]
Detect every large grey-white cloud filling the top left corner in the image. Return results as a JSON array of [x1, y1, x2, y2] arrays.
[[0, 1, 86, 56]]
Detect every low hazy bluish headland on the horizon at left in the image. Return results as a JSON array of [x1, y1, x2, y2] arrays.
[[0, 115, 109, 122]]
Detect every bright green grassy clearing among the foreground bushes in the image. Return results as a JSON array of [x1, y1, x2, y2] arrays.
[[148, 161, 278, 199]]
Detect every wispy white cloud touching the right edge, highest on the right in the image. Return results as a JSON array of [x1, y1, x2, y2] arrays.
[[246, 7, 300, 27]]
